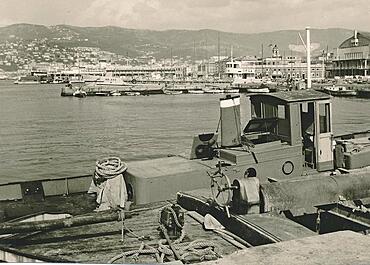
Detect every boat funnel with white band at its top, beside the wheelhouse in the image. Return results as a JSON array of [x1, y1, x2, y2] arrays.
[[220, 95, 241, 147]]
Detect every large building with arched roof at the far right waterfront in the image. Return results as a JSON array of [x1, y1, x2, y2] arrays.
[[330, 30, 370, 77]]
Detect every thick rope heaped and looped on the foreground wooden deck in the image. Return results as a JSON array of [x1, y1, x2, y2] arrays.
[[108, 203, 220, 263]]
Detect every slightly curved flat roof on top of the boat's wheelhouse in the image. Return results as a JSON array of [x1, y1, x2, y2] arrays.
[[251, 90, 330, 103]]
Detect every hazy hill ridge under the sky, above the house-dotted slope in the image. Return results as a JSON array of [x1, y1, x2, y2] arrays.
[[0, 24, 358, 59]]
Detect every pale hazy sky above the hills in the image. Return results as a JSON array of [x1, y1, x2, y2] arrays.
[[0, 0, 370, 33]]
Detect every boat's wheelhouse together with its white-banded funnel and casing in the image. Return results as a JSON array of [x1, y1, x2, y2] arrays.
[[219, 90, 334, 183]]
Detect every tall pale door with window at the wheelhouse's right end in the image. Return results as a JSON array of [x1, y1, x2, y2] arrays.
[[315, 100, 334, 171]]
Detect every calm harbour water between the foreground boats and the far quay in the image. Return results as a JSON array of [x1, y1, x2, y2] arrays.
[[0, 82, 370, 179]]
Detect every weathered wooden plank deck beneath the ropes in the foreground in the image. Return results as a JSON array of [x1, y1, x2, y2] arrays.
[[0, 202, 238, 263]]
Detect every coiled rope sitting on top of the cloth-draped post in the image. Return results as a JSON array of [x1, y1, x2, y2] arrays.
[[93, 157, 127, 185]]
